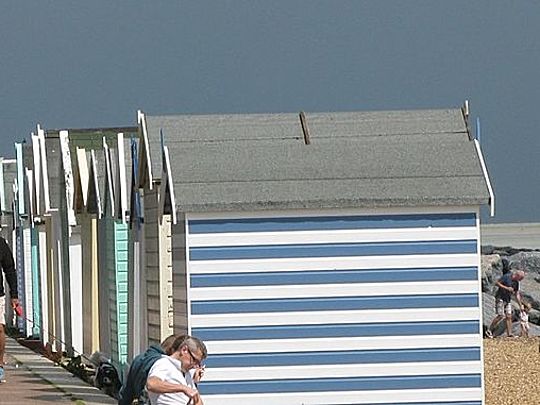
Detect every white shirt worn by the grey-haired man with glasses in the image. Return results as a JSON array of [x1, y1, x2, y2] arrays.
[[148, 355, 195, 405]]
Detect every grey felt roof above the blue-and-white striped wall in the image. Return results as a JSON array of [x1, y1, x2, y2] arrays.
[[142, 109, 489, 212]]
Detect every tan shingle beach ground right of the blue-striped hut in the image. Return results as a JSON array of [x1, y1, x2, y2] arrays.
[[484, 337, 540, 405]]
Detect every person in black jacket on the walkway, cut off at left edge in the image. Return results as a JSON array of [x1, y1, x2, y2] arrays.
[[0, 237, 19, 383]]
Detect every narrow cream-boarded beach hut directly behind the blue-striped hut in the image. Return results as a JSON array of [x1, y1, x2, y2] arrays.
[[137, 111, 173, 351]]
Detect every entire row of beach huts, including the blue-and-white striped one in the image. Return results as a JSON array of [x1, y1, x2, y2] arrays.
[[0, 104, 494, 405]]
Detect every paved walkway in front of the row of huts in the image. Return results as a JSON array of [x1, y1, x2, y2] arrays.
[[0, 337, 117, 405]]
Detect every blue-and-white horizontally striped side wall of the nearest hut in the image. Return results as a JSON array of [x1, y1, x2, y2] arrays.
[[186, 213, 483, 405]]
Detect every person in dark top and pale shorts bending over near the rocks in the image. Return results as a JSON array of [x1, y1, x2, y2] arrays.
[[486, 270, 525, 338]]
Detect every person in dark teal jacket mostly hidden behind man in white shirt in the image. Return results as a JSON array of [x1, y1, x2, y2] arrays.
[[118, 335, 187, 405]]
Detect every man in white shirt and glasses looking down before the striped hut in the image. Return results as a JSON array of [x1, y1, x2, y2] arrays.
[[146, 336, 208, 405]]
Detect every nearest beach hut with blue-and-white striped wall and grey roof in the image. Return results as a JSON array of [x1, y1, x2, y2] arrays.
[[150, 108, 494, 405]]
